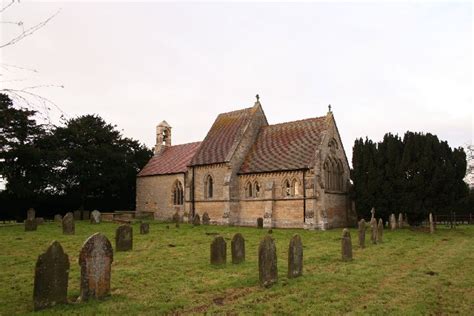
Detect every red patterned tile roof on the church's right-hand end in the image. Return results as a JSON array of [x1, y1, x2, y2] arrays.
[[240, 116, 327, 173]]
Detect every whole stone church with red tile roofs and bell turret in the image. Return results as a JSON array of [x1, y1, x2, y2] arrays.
[[136, 96, 357, 229]]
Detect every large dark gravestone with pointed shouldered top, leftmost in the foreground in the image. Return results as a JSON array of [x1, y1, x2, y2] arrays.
[[33, 241, 69, 311]]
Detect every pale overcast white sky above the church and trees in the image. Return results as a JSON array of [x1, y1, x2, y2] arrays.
[[0, 0, 474, 160]]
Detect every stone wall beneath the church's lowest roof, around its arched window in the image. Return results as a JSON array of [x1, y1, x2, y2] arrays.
[[136, 173, 184, 220]]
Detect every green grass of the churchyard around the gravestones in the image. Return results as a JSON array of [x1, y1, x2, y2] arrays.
[[0, 222, 474, 315]]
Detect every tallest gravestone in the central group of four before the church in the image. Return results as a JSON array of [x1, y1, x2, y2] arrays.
[[258, 235, 278, 287]]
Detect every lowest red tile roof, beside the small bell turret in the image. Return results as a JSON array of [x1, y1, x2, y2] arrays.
[[138, 142, 201, 177]]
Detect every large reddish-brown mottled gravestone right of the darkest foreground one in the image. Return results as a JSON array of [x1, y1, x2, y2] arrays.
[[79, 233, 114, 301]]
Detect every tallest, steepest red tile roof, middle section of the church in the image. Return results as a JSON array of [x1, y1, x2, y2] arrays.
[[191, 108, 253, 166]]
